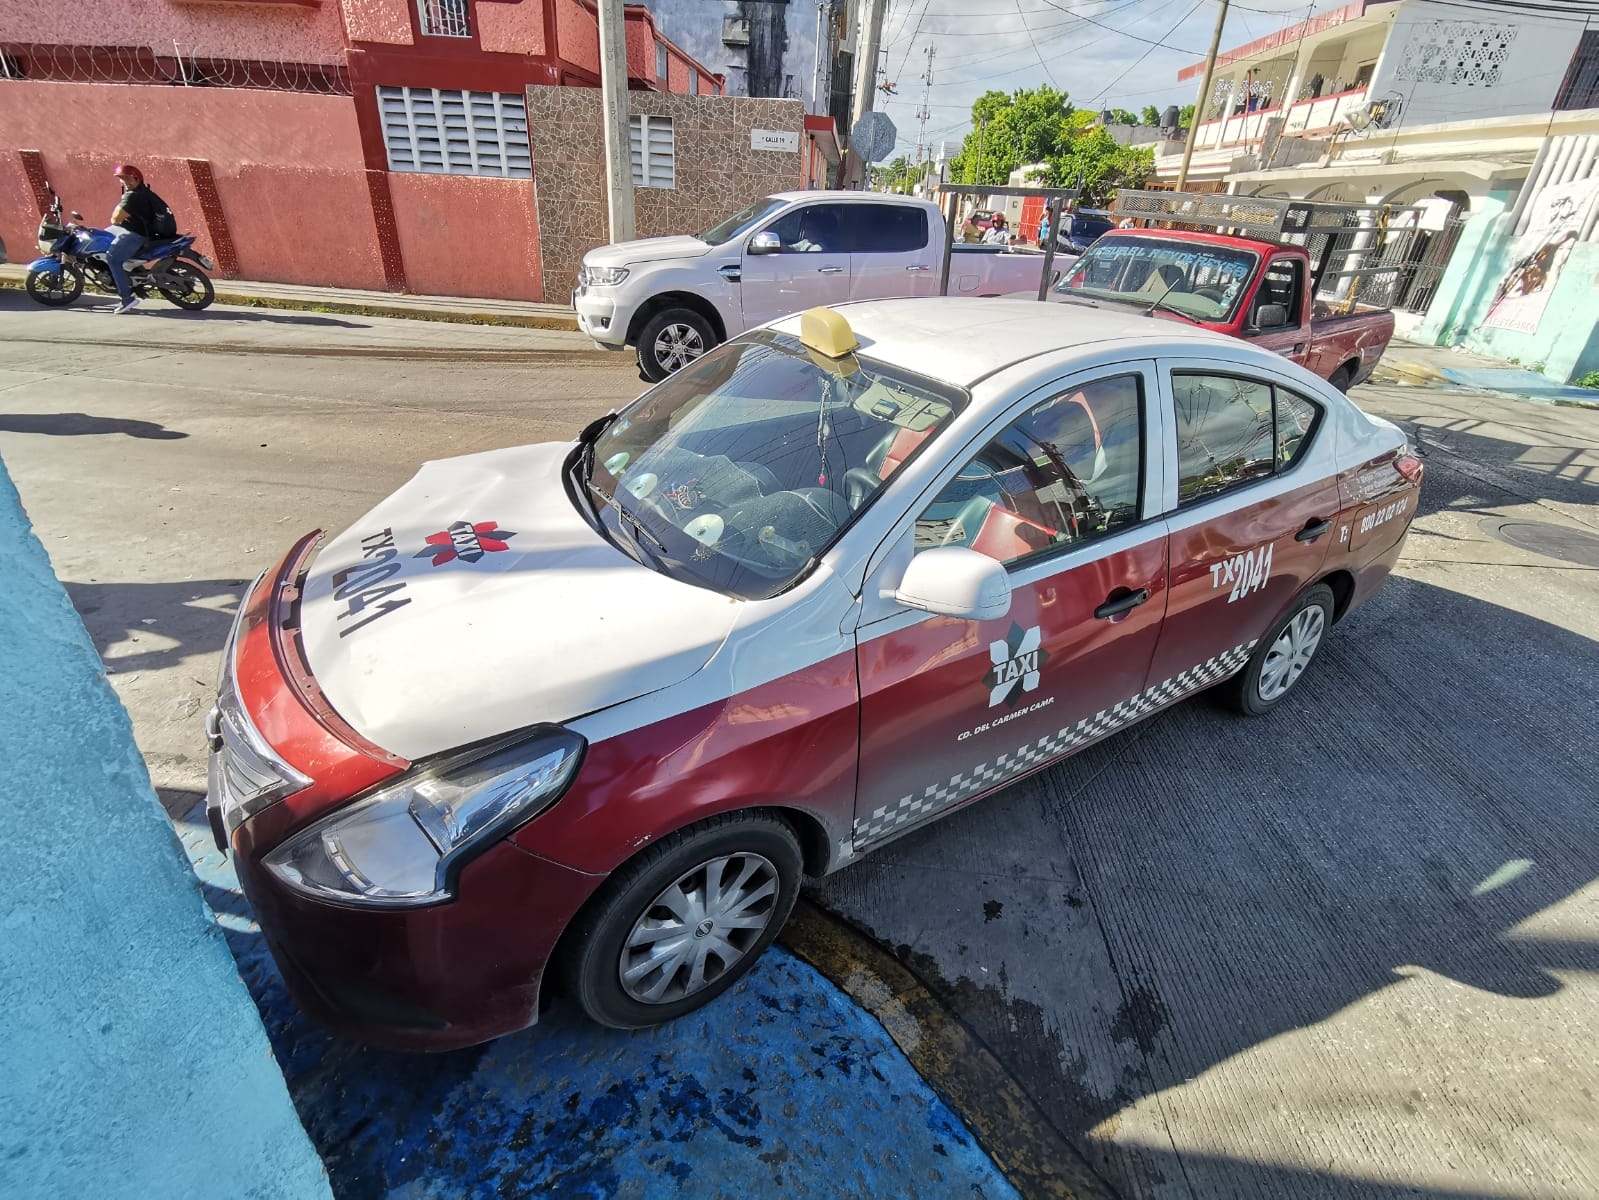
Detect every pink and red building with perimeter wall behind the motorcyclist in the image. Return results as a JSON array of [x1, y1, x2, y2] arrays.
[[0, 0, 724, 299]]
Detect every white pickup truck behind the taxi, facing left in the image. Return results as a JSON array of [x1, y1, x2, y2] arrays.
[[572, 192, 1044, 382]]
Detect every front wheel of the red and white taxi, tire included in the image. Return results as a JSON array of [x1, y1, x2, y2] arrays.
[[564, 811, 803, 1029]]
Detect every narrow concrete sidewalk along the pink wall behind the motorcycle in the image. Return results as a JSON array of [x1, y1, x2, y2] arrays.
[[0, 262, 577, 331]]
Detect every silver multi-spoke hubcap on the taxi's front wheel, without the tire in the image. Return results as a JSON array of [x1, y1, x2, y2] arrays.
[[620, 854, 777, 1005]]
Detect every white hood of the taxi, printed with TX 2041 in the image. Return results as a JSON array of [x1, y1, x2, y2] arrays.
[[301, 445, 739, 758]]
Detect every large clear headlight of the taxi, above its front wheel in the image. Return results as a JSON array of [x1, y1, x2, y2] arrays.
[[264, 726, 585, 907]]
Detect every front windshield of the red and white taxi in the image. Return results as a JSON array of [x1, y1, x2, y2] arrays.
[[588, 334, 964, 598]]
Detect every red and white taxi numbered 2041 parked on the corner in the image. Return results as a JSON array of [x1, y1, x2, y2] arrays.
[[209, 299, 1422, 1050]]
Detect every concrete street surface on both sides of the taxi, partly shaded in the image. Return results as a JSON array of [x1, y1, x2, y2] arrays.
[[0, 293, 1599, 1197]]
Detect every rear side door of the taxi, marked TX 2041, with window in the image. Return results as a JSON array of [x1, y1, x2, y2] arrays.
[[1151, 358, 1340, 682]]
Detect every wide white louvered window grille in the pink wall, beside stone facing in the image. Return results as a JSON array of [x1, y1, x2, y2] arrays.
[[377, 86, 532, 179]]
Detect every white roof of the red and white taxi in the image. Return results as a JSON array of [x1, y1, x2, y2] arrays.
[[774, 296, 1244, 387]]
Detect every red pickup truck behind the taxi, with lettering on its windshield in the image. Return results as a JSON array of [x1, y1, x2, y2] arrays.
[[1049, 229, 1394, 392]]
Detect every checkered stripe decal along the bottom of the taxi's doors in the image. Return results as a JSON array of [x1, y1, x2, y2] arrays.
[[854, 642, 1255, 850]]
